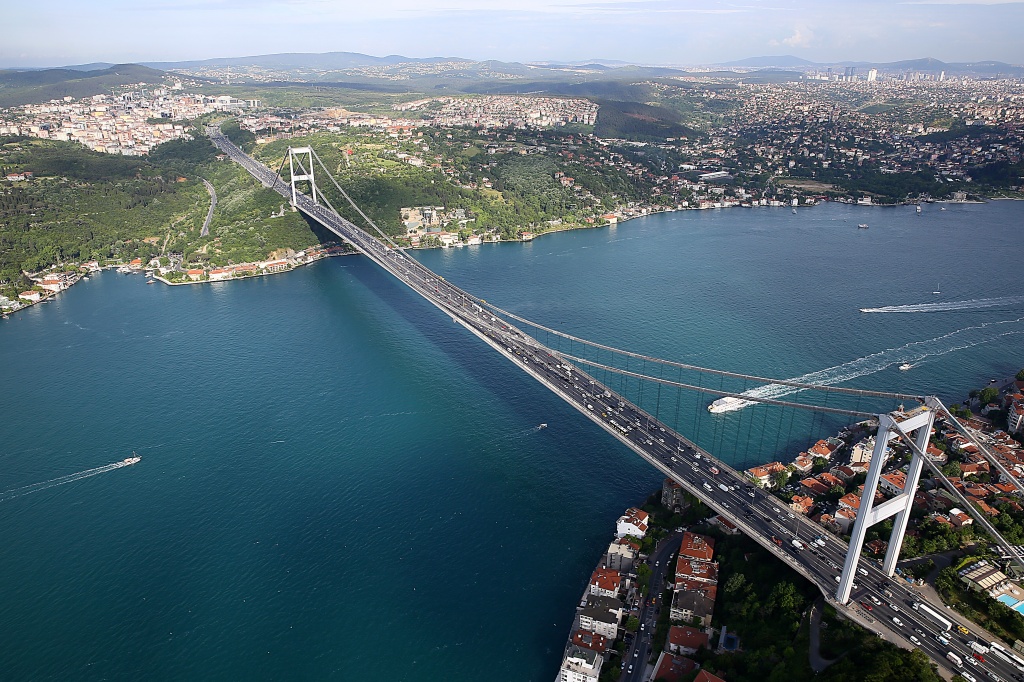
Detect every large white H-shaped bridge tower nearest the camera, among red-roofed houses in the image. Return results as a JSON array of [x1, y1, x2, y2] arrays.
[[836, 398, 938, 604]]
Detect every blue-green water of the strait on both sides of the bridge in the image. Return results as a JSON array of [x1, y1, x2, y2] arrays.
[[0, 203, 1024, 680]]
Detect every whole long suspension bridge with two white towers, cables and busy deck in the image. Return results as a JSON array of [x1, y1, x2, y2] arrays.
[[207, 126, 1024, 676]]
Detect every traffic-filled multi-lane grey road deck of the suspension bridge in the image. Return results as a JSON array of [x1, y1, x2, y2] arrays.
[[207, 126, 1024, 679]]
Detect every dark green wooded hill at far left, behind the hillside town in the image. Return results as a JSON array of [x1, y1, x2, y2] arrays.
[[0, 63, 164, 106]]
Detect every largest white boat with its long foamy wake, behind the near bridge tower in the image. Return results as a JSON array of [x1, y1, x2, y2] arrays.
[[708, 317, 1024, 413]]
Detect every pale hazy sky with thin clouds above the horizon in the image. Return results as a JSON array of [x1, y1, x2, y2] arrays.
[[0, 0, 1024, 68]]
